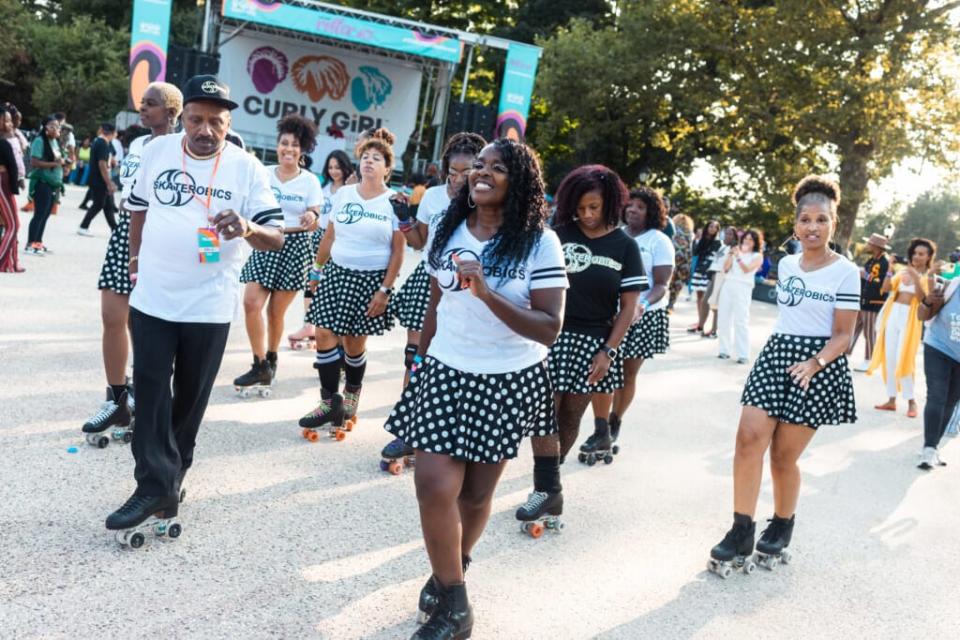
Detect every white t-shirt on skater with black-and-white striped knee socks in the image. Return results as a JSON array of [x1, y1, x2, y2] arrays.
[[330, 184, 400, 271]]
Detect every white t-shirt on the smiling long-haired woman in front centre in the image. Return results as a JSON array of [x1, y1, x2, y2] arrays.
[[424, 222, 568, 373]]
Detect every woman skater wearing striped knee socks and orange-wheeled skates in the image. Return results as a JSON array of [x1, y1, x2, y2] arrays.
[[300, 129, 406, 440]]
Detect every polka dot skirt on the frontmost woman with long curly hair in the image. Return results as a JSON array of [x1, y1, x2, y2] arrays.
[[384, 356, 557, 464]]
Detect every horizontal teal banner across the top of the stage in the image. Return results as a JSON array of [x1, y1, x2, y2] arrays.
[[226, 0, 461, 64]]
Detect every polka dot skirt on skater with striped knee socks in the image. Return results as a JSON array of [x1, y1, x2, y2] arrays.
[[307, 260, 393, 336]]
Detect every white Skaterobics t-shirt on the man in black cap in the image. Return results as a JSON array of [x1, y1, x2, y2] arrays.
[[127, 133, 283, 323]]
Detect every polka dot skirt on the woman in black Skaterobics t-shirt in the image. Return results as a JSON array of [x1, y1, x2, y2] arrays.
[[547, 331, 623, 393]]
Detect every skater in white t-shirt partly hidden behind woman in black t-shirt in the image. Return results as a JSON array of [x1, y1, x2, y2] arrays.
[[608, 187, 676, 440]]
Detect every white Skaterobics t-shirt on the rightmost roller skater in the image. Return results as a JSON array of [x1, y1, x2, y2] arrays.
[[773, 253, 860, 337]]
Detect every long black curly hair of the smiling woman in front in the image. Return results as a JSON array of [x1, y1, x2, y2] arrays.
[[429, 138, 547, 269]]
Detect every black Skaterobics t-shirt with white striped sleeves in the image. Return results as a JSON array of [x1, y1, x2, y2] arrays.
[[556, 224, 643, 338]]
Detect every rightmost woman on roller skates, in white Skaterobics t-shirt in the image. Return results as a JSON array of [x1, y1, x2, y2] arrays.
[[709, 176, 860, 577]]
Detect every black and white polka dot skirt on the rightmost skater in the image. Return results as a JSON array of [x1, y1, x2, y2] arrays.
[[740, 333, 857, 429]]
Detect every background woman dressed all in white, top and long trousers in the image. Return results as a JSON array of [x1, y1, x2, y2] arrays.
[[717, 229, 763, 364]]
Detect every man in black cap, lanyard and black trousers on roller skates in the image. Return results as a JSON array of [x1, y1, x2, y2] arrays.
[[107, 75, 283, 546]]
